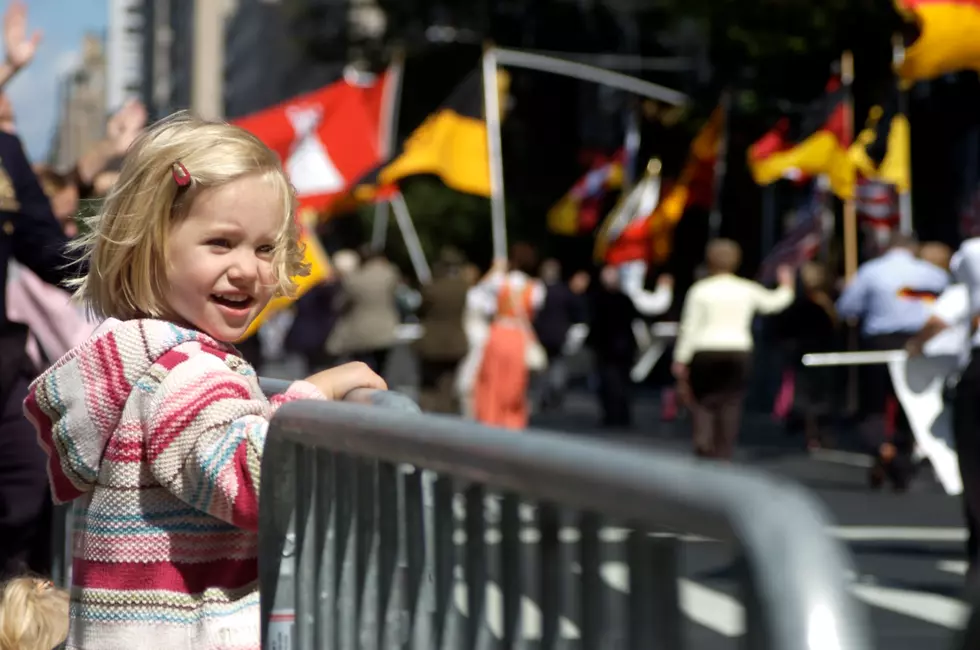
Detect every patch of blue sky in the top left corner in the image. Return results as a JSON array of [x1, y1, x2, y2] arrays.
[[0, 0, 108, 161]]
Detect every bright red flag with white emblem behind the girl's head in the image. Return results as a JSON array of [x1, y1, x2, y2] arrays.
[[235, 73, 390, 211]]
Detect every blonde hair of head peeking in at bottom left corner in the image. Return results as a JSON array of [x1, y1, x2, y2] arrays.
[[0, 578, 69, 650]]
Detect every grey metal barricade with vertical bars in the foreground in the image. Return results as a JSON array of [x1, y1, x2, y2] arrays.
[[259, 388, 872, 650]]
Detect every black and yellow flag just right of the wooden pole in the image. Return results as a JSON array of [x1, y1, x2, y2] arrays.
[[848, 89, 912, 194]]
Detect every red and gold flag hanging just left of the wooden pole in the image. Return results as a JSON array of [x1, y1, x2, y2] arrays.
[[748, 79, 853, 196]]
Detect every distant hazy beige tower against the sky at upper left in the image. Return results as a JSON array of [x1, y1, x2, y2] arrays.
[[49, 34, 106, 170]]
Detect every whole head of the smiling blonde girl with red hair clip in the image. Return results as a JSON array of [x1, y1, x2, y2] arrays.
[[76, 113, 306, 342]]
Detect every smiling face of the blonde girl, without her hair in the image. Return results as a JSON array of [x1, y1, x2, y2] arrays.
[[167, 175, 287, 342]]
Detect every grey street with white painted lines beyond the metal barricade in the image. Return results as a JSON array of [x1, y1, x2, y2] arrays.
[[267, 352, 967, 650]]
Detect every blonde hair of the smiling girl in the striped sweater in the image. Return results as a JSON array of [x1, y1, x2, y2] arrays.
[[72, 112, 309, 320]]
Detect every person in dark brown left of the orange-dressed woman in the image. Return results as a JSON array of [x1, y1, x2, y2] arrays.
[[414, 248, 470, 415]]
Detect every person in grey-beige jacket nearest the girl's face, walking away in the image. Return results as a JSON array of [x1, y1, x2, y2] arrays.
[[327, 248, 400, 374]]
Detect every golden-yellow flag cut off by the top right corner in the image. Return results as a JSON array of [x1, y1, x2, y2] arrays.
[[895, 0, 980, 81]]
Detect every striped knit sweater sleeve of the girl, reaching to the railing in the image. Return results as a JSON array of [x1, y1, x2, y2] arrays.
[[141, 350, 323, 531]]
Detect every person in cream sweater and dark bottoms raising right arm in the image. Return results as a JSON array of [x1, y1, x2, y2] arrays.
[[673, 239, 795, 459]]
